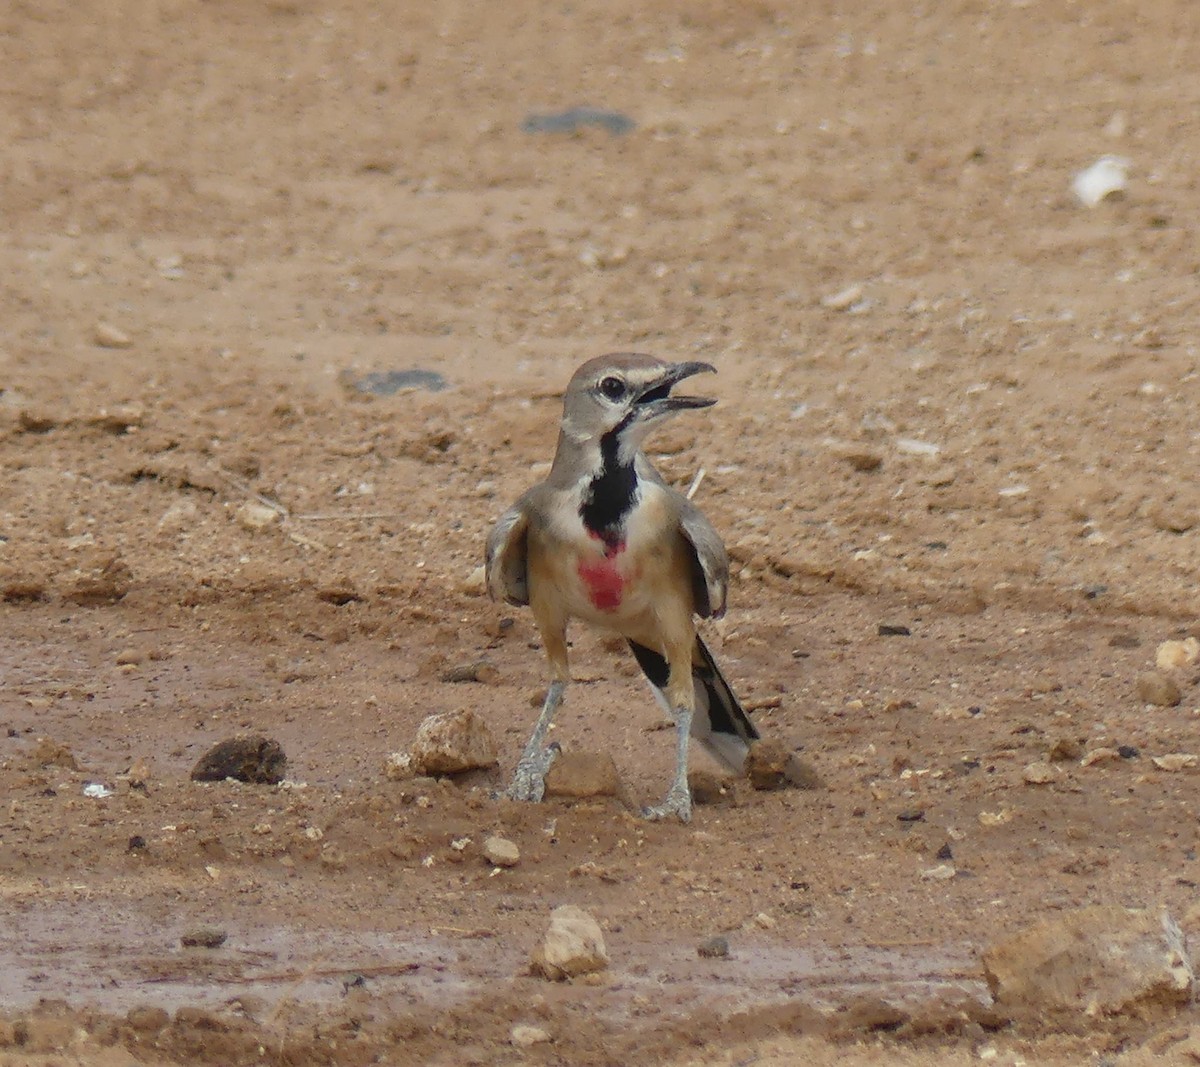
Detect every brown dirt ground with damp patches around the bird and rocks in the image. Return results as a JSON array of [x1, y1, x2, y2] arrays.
[[7, 0, 1200, 1067]]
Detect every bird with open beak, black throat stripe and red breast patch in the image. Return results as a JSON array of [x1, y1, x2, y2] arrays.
[[485, 353, 760, 822]]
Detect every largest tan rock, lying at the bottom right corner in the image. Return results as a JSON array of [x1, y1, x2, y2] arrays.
[[983, 905, 1194, 1023]]
